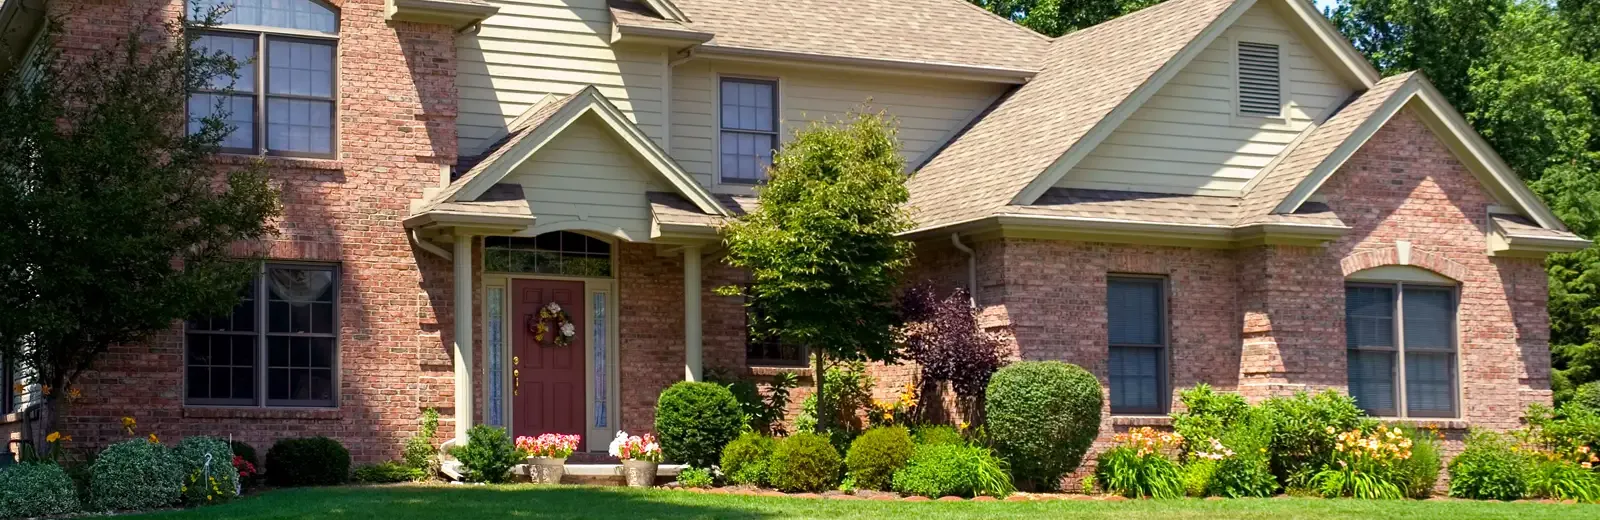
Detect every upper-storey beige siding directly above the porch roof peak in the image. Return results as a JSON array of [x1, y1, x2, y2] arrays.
[[456, 0, 667, 155]]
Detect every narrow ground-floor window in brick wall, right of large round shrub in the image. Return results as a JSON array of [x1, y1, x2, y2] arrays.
[[1106, 277, 1168, 414]]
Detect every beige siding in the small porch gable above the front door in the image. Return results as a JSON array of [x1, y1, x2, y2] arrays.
[[506, 114, 672, 240]]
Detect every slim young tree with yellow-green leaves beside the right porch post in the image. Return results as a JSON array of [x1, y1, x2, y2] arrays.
[[720, 110, 912, 427]]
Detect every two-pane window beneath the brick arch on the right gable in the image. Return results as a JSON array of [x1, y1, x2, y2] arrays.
[[1344, 283, 1456, 418]]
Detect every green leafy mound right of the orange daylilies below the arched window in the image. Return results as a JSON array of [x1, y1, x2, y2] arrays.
[[1450, 432, 1528, 501]]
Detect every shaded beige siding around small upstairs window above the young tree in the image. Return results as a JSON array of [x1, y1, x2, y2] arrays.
[[670, 59, 1005, 190]]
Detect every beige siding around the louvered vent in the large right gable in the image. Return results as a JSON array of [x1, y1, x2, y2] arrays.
[[1056, 3, 1352, 195]]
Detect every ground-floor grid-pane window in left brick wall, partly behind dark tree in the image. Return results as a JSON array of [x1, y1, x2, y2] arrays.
[[184, 264, 339, 406]]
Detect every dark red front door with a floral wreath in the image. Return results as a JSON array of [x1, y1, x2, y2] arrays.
[[512, 280, 587, 442]]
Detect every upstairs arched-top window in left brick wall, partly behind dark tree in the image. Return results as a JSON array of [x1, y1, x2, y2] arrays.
[[189, 0, 339, 157]]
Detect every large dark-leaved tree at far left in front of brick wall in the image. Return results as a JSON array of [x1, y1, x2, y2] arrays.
[[0, 15, 280, 450]]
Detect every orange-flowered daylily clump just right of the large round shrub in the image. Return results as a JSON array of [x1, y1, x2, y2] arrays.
[[1094, 427, 1184, 498]]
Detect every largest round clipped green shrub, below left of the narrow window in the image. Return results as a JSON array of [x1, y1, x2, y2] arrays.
[[984, 362, 1102, 488]]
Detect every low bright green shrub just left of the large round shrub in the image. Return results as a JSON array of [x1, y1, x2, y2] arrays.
[[893, 443, 1016, 498]]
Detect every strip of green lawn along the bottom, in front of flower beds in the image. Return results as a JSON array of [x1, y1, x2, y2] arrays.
[[121, 485, 1600, 520]]
